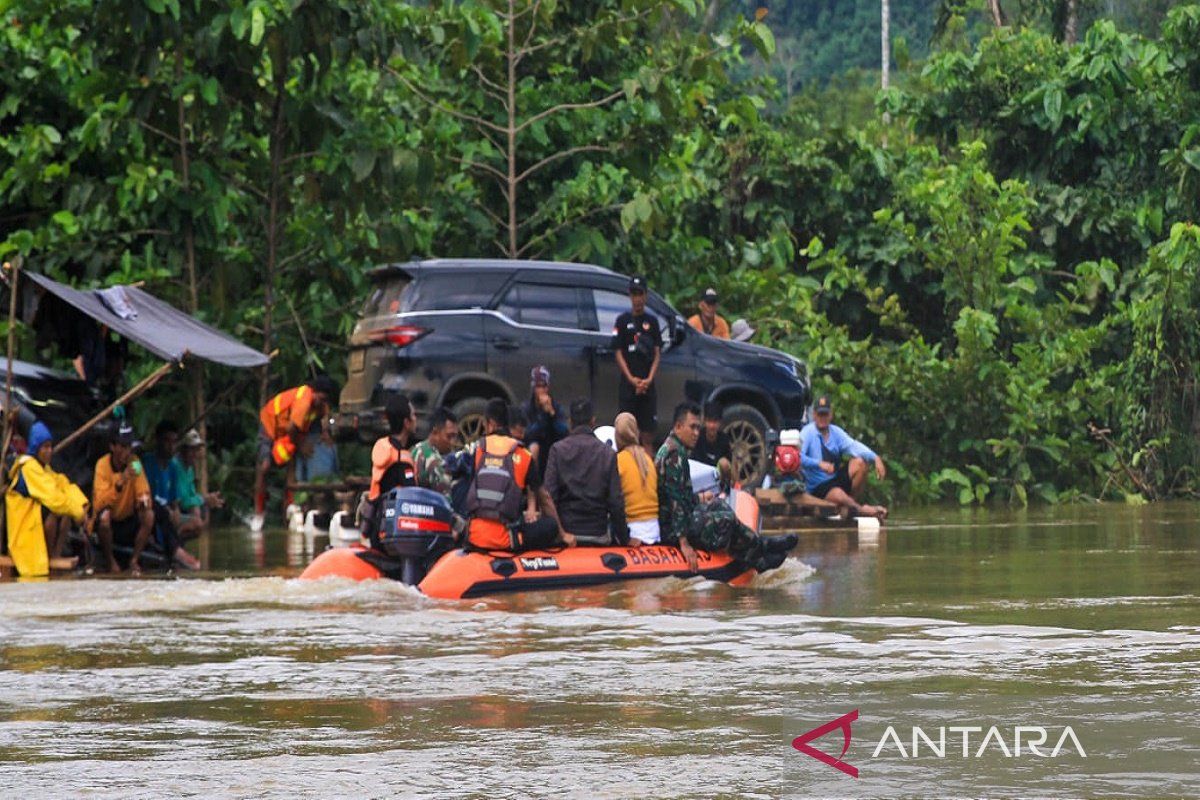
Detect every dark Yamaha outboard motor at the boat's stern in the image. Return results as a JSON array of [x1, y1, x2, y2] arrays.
[[371, 486, 454, 587]]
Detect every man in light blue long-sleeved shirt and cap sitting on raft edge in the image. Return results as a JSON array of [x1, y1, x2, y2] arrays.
[[800, 396, 888, 519]]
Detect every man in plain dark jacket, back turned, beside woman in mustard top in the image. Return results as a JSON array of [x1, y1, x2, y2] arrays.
[[545, 397, 629, 546]]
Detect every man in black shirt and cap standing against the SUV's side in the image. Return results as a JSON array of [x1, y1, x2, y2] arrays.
[[612, 276, 662, 449]]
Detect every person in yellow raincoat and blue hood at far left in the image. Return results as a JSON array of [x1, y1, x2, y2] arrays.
[[5, 422, 88, 577]]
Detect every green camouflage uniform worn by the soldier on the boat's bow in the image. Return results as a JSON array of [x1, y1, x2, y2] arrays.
[[654, 433, 772, 572]]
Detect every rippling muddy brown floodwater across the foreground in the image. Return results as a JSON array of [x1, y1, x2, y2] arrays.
[[0, 504, 1200, 800]]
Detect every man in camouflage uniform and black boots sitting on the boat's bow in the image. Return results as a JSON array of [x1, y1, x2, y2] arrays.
[[654, 403, 799, 572]]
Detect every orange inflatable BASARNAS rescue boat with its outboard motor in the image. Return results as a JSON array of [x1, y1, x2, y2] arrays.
[[300, 488, 758, 600]]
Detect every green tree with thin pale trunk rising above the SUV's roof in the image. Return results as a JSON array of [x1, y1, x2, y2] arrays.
[[390, 0, 772, 258]]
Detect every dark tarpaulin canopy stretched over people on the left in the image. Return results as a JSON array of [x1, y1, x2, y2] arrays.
[[22, 272, 269, 367]]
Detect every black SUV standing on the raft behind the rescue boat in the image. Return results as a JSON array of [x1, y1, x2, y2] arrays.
[[338, 259, 809, 485]]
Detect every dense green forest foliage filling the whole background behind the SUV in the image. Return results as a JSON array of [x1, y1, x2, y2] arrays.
[[0, 0, 1200, 503]]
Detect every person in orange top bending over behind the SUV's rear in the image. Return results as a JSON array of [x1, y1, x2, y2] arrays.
[[250, 375, 337, 530]]
